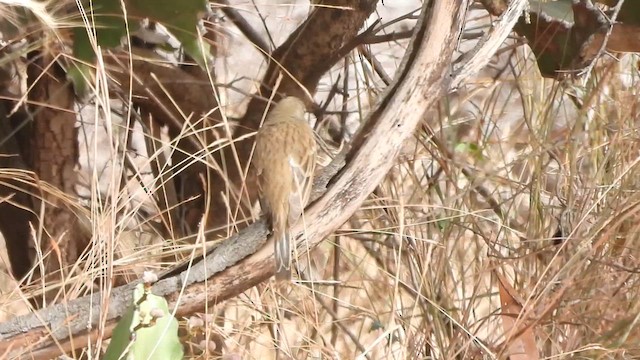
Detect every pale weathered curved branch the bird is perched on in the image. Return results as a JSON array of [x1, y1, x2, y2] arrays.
[[0, 0, 476, 358]]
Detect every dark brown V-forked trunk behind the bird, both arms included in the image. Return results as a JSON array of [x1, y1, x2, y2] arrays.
[[110, 0, 377, 237]]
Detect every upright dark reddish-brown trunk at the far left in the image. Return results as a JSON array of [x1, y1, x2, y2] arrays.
[[27, 52, 87, 284]]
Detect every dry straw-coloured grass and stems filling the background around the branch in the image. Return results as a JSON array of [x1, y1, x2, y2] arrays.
[[0, 1, 640, 359]]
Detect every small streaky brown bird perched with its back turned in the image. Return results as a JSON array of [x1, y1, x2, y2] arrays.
[[253, 96, 316, 280]]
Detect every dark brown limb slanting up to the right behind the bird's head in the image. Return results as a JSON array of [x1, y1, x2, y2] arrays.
[[201, 0, 377, 233]]
